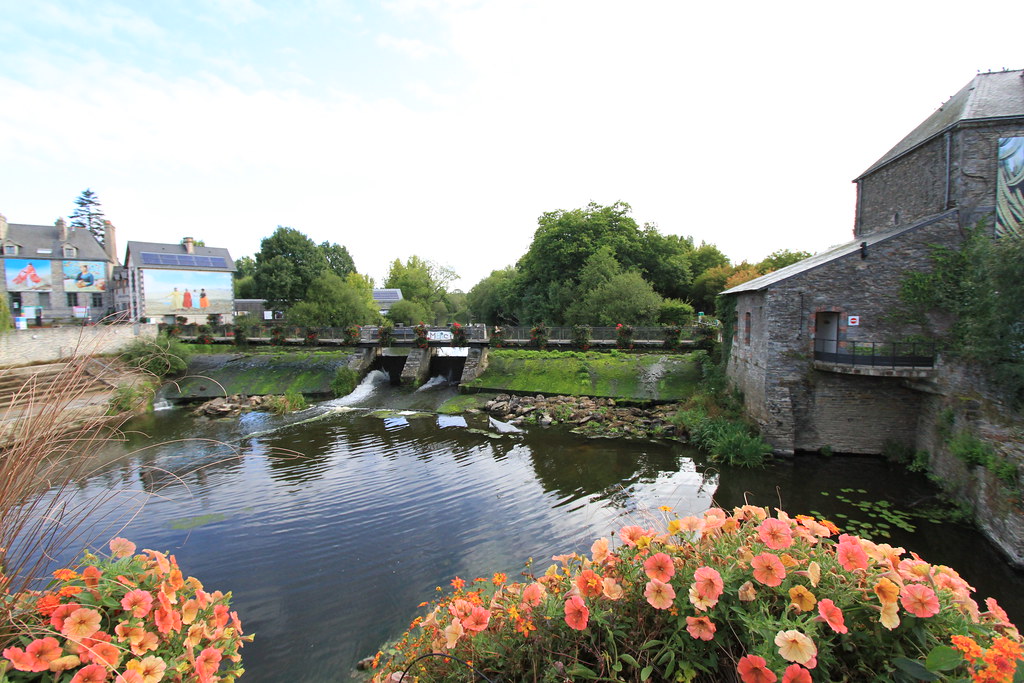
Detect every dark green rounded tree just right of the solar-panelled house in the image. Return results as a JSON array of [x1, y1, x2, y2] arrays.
[[253, 225, 329, 309]]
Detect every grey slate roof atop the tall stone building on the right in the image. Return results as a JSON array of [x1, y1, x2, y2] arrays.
[[856, 70, 1024, 180]]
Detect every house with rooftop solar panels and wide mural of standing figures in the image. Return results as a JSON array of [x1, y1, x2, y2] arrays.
[[117, 238, 234, 324]]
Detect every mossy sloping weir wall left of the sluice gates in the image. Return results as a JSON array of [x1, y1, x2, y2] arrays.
[[160, 349, 353, 400]]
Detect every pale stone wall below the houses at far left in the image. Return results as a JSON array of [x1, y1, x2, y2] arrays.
[[0, 324, 157, 368]]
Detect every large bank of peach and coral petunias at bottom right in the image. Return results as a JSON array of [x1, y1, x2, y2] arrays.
[[374, 506, 1021, 683]]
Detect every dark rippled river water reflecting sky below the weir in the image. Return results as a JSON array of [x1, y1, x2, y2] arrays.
[[37, 376, 1024, 683]]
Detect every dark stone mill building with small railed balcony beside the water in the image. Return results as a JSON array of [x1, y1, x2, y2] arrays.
[[724, 71, 1024, 454]]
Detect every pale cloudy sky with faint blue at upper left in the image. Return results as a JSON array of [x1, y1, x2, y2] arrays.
[[0, 0, 1024, 291]]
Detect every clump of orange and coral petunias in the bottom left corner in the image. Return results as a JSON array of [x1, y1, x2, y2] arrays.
[[0, 539, 252, 683]]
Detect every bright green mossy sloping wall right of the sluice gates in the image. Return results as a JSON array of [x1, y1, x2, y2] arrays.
[[464, 349, 700, 401]]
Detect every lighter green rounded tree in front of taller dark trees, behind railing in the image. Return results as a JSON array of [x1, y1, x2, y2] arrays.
[[288, 268, 378, 328]]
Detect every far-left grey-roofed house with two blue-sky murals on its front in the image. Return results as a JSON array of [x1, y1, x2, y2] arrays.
[[0, 216, 118, 323]]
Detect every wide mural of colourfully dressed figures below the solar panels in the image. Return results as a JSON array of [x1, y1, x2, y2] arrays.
[[143, 269, 234, 315]]
